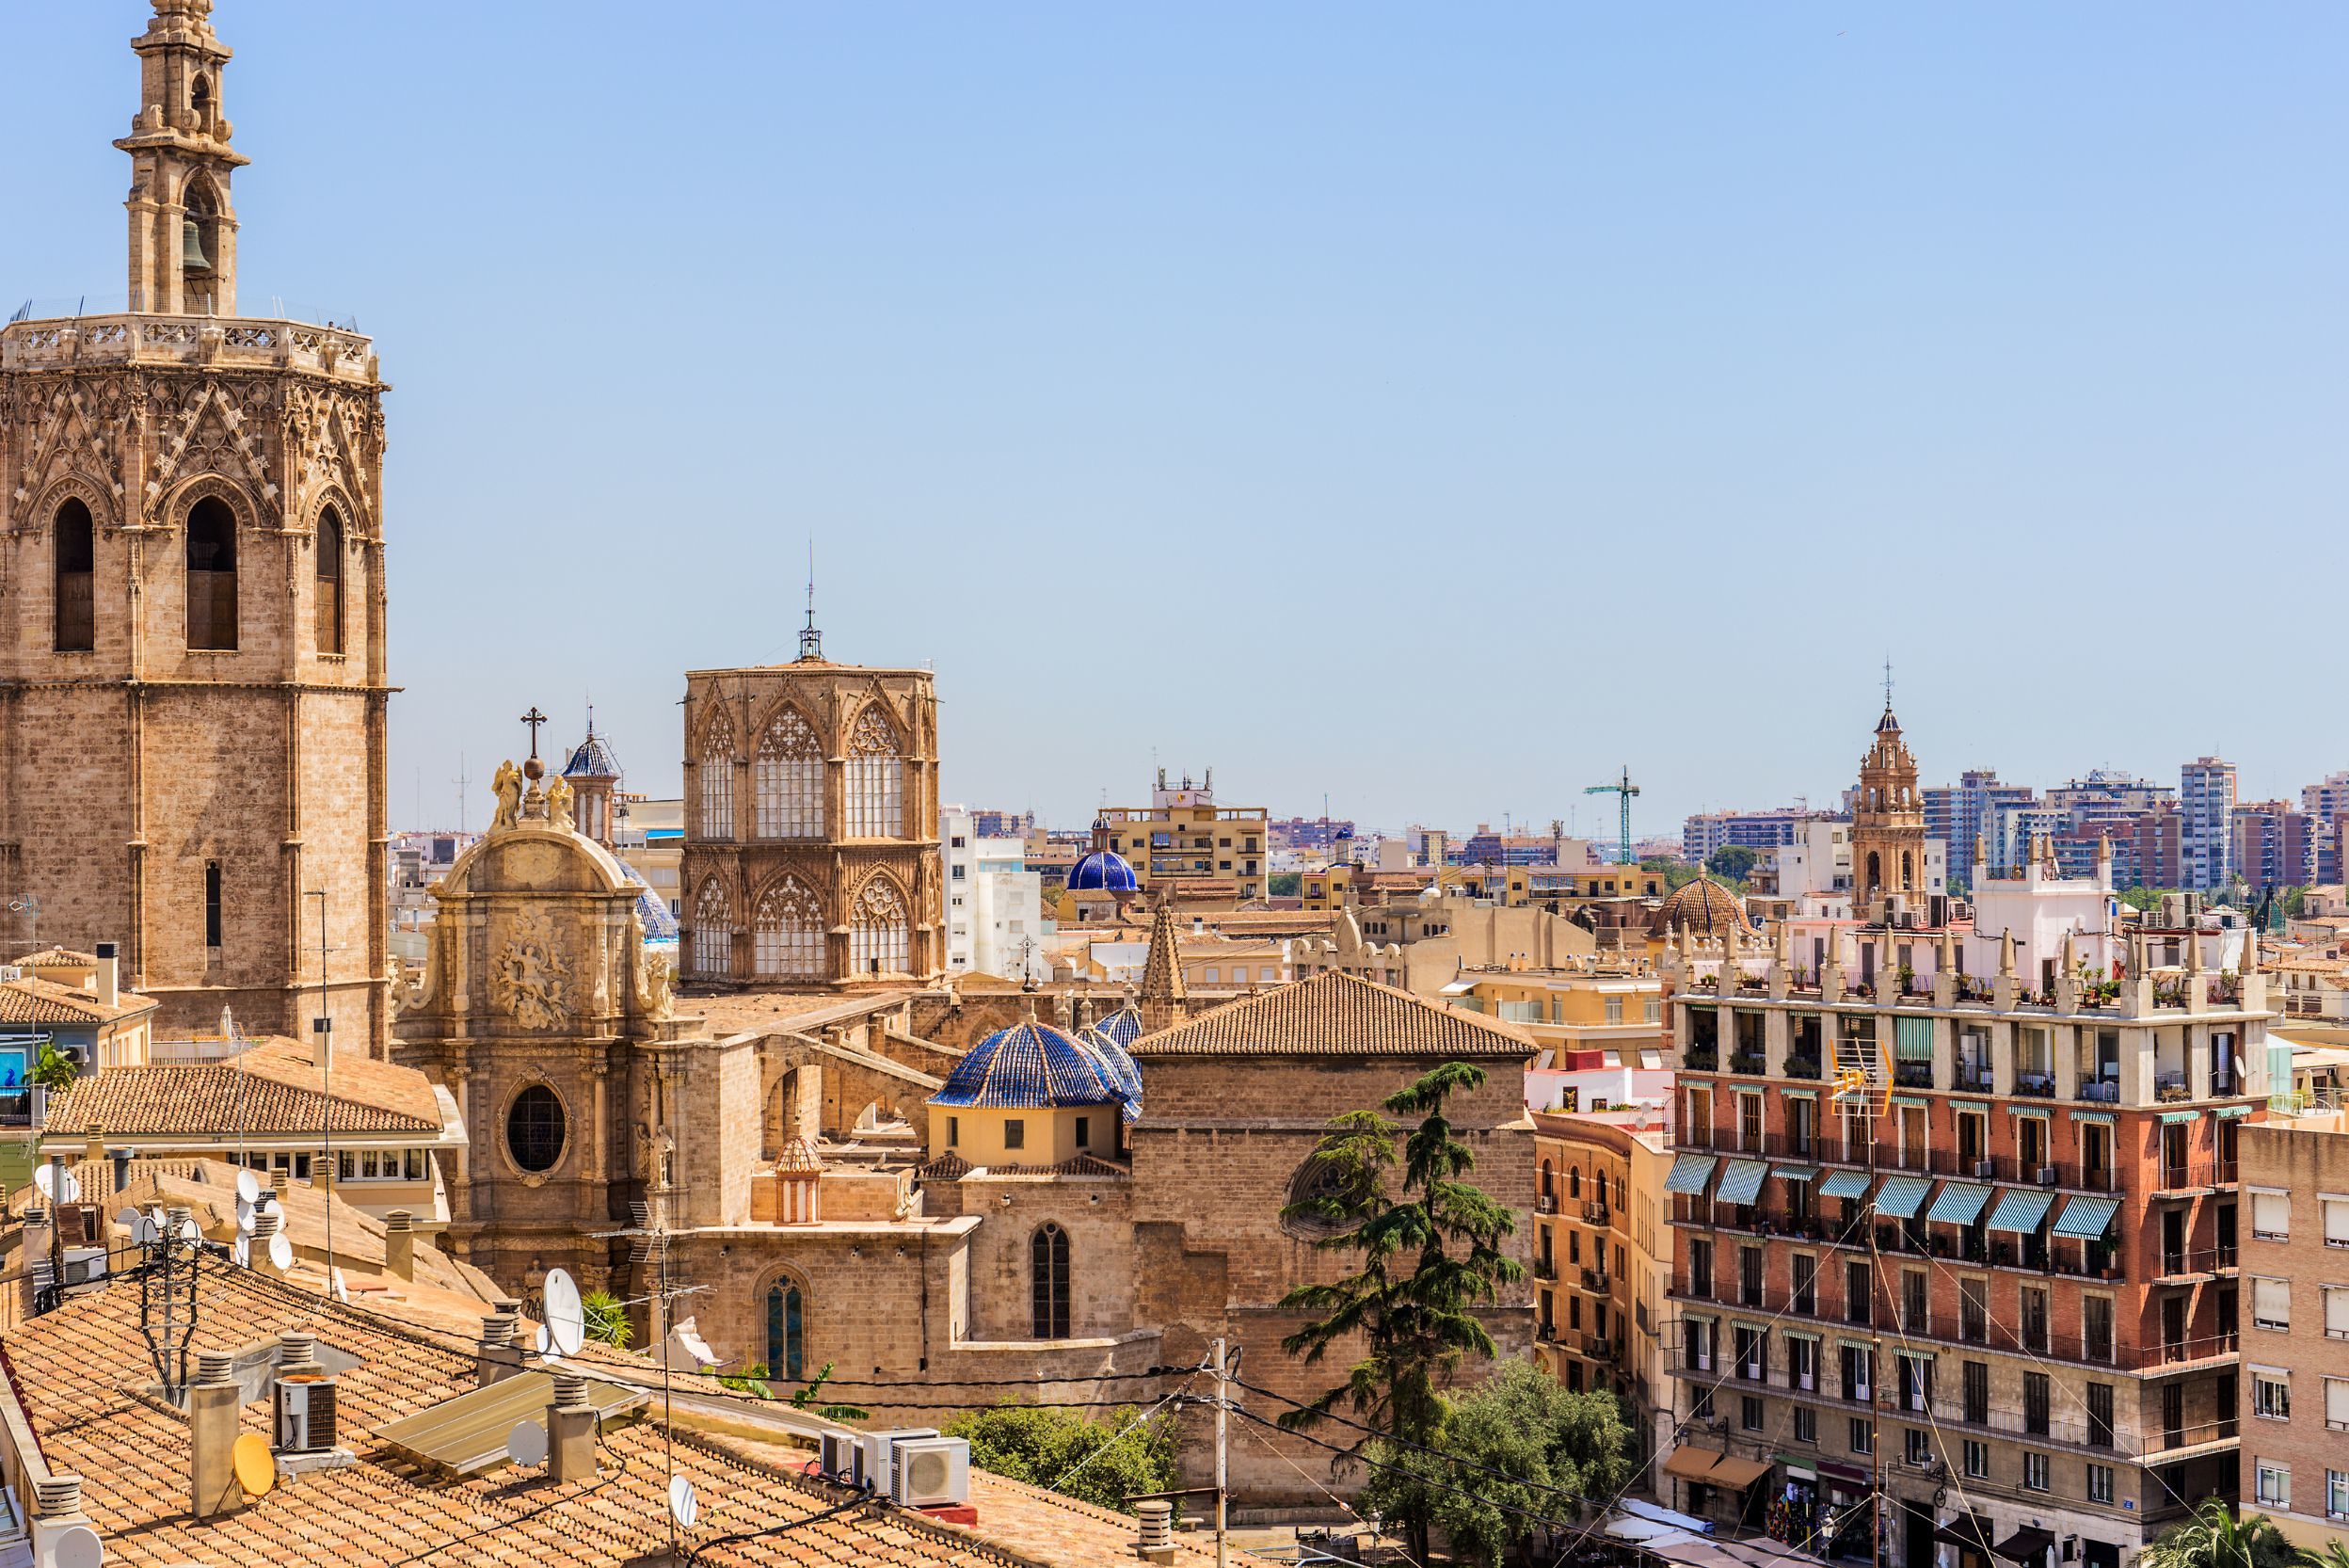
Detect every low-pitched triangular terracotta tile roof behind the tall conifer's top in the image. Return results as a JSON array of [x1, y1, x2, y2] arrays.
[[1132, 971, 1534, 1060]]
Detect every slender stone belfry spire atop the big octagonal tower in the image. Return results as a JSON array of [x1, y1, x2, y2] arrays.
[[115, 0, 251, 315]]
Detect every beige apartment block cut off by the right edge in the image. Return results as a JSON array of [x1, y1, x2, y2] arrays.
[[2241, 1100, 2349, 1552]]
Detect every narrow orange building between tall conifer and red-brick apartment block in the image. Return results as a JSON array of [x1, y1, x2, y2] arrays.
[[1534, 1110, 1672, 1488]]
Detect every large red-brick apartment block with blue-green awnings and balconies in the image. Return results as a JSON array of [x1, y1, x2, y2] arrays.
[[1663, 714, 2272, 1568]]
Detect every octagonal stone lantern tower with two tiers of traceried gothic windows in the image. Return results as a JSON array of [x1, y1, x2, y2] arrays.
[[679, 634, 947, 987]]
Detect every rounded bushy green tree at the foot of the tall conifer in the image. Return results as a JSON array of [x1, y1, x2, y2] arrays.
[[1363, 1361, 1630, 1568]]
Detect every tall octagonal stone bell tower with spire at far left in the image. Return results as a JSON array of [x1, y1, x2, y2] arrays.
[[0, 0, 390, 1055]]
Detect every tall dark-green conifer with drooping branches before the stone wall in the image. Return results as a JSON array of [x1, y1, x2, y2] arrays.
[[1280, 1063, 1525, 1561]]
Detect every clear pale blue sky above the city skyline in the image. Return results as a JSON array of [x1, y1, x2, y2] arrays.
[[0, 0, 2349, 832]]
